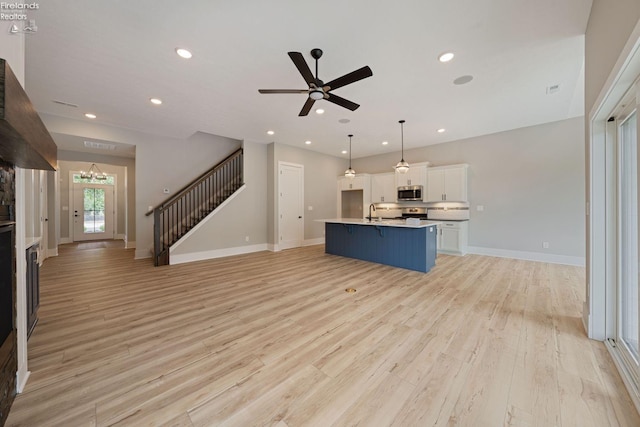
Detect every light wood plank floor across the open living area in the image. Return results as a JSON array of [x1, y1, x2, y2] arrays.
[[7, 243, 640, 427]]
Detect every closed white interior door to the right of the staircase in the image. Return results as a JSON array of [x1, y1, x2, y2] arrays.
[[278, 163, 304, 249]]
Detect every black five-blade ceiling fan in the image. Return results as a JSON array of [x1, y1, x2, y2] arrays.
[[258, 49, 373, 116]]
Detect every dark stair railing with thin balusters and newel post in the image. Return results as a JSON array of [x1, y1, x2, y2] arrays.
[[146, 148, 244, 266]]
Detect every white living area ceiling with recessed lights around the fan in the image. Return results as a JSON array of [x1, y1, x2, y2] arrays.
[[26, 0, 591, 158]]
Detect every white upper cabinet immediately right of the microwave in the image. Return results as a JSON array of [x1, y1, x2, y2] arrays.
[[425, 164, 469, 202]]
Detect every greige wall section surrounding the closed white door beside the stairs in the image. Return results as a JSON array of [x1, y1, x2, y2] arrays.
[[270, 143, 348, 244]]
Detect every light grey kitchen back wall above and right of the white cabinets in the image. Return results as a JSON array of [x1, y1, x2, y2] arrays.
[[353, 117, 585, 264]]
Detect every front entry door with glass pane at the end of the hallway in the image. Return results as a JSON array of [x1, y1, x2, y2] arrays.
[[72, 183, 115, 241]]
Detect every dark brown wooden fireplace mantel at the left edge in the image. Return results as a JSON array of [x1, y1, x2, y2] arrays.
[[0, 58, 58, 171]]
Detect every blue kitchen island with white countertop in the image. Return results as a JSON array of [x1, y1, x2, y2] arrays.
[[318, 218, 440, 273]]
